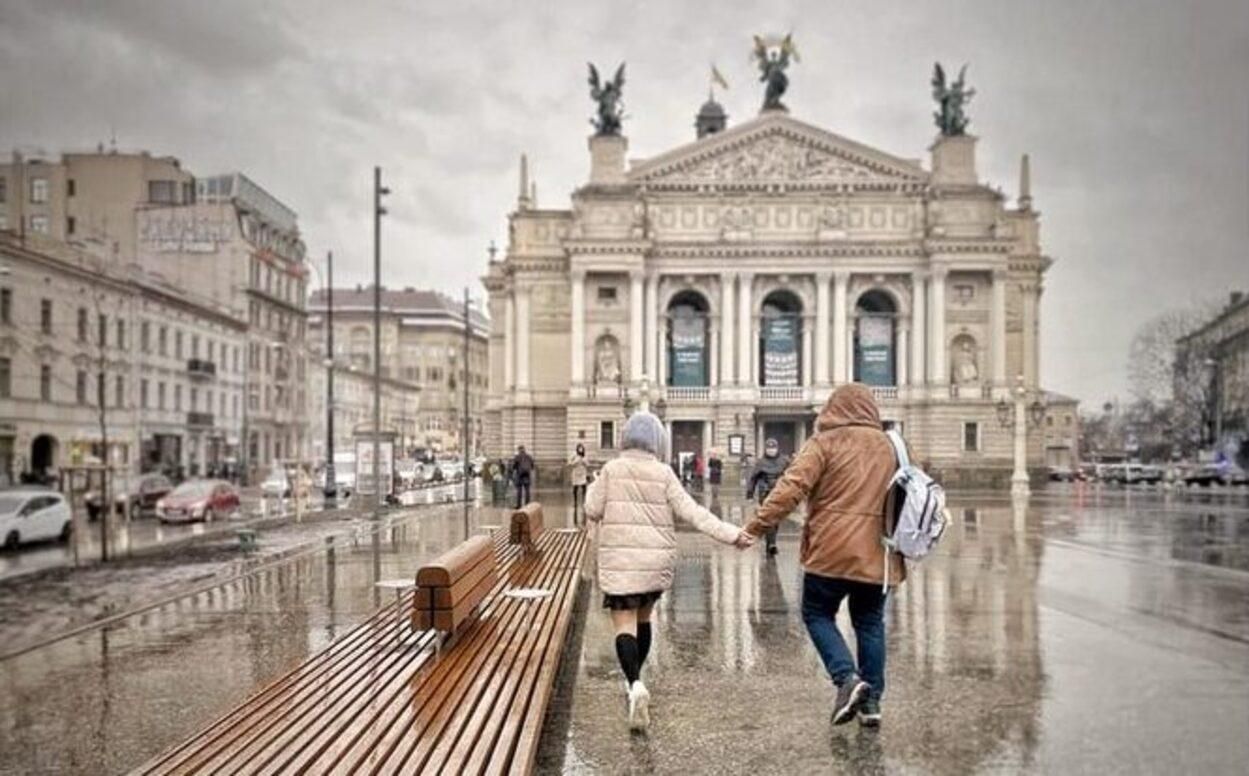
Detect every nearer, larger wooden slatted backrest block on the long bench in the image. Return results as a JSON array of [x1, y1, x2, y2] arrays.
[[412, 536, 498, 634]]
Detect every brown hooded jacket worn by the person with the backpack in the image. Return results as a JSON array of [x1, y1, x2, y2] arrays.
[[746, 382, 906, 586]]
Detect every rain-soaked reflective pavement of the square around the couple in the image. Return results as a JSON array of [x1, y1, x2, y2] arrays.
[[0, 490, 1249, 774]]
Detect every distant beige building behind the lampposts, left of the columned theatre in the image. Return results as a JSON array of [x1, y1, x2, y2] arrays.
[[309, 286, 490, 452]]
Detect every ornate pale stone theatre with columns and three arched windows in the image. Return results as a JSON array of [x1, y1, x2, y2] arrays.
[[483, 77, 1050, 485]]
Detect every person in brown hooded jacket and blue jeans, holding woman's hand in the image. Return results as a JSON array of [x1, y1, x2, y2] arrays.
[[746, 384, 906, 726]]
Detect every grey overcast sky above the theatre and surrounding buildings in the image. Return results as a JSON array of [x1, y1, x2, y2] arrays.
[[0, 0, 1249, 406]]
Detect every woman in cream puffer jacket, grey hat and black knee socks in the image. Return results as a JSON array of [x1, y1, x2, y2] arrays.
[[586, 412, 752, 730]]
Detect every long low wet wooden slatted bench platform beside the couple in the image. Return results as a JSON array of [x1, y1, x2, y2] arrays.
[[136, 529, 586, 774]]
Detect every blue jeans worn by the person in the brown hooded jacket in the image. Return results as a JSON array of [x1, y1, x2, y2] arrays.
[[802, 574, 886, 700]]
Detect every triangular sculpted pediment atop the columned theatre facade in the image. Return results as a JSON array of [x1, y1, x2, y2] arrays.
[[628, 112, 928, 186]]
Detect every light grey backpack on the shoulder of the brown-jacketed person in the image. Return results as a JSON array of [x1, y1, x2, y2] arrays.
[[881, 430, 949, 594]]
